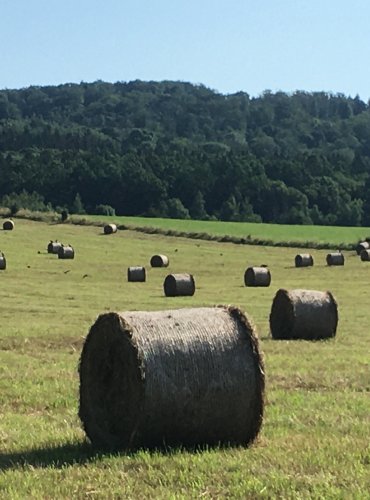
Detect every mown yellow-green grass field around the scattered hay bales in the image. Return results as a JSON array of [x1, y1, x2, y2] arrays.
[[0, 218, 370, 499]]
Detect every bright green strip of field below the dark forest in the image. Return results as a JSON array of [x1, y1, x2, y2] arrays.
[[87, 215, 370, 245]]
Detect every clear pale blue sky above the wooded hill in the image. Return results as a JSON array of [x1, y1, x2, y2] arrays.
[[0, 0, 370, 101]]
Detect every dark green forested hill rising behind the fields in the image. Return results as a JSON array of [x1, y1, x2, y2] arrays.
[[0, 81, 370, 225]]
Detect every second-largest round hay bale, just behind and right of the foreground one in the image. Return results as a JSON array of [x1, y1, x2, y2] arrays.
[[270, 289, 338, 340]]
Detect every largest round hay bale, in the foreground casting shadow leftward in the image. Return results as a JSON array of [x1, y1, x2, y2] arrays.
[[79, 307, 264, 449]]
